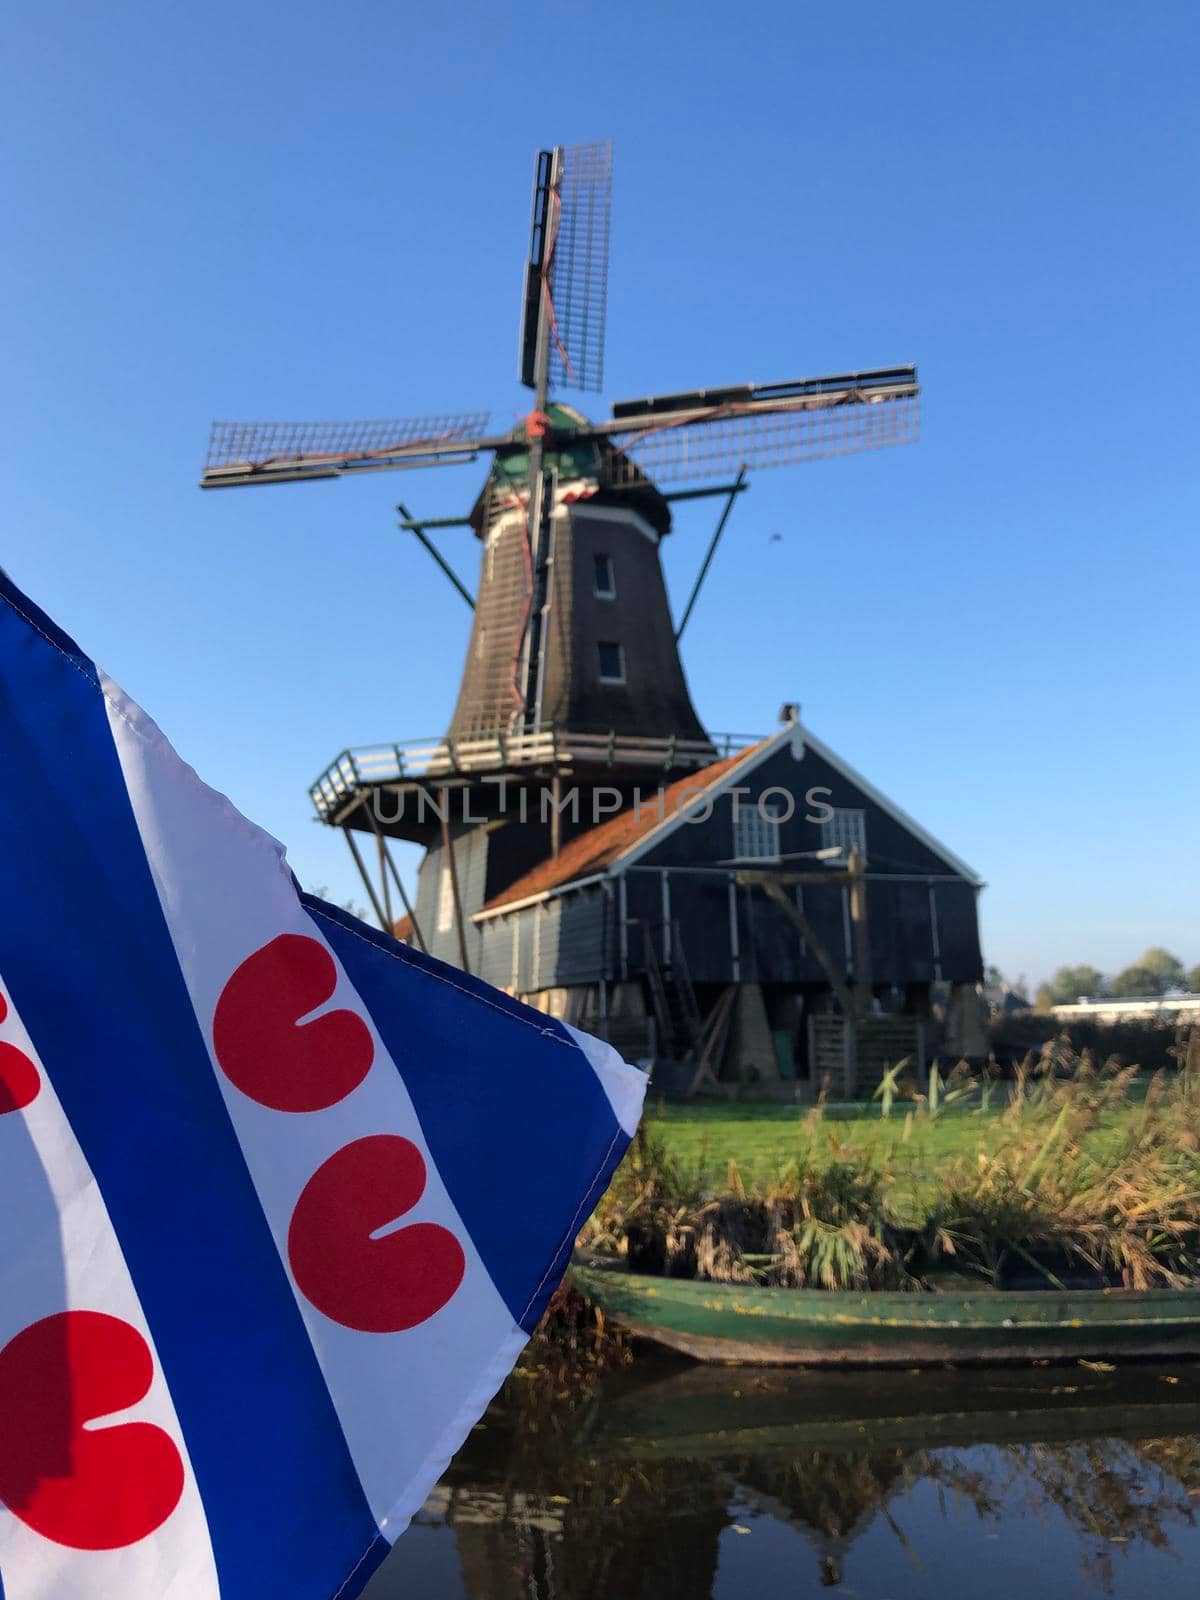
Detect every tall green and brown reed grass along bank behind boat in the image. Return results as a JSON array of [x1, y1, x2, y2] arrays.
[[581, 1050, 1200, 1291]]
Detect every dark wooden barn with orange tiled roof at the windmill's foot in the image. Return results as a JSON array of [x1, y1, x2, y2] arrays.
[[398, 718, 982, 1093]]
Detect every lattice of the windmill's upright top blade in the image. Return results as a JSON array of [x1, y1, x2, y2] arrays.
[[549, 139, 613, 390]]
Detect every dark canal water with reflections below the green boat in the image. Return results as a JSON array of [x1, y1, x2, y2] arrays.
[[366, 1358, 1200, 1600]]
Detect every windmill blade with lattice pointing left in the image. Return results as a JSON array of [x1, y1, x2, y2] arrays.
[[200, 411, 488, 488]]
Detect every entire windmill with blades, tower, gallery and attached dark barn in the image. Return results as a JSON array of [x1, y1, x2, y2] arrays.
[[202, 146, 984, 1096]]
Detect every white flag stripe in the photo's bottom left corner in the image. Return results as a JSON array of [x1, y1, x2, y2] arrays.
[[0, 974, 219, 1600]]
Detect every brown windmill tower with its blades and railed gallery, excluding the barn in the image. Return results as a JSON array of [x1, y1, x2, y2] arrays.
[[202, 142, 918, 965]]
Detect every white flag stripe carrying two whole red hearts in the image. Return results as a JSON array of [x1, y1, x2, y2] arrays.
[[102, 680, 526, 1539]]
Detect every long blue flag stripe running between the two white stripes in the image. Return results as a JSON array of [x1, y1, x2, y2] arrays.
[[0, 578, 386, 1600]]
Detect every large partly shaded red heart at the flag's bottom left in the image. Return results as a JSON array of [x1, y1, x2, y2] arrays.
[[0, 1310, 184, 1550]]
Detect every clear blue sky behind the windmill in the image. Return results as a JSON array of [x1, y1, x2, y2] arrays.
[[0, 0, 1200, 979]]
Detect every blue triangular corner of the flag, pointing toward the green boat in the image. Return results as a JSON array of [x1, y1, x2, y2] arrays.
[[301, 894, 629, 1331]]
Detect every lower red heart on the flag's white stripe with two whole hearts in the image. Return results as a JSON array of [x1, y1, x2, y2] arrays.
[[288, 1133, 467, 1333]]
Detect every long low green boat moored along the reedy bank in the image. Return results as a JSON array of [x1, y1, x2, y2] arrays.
[[571, 1258, 1200, 1366]]
